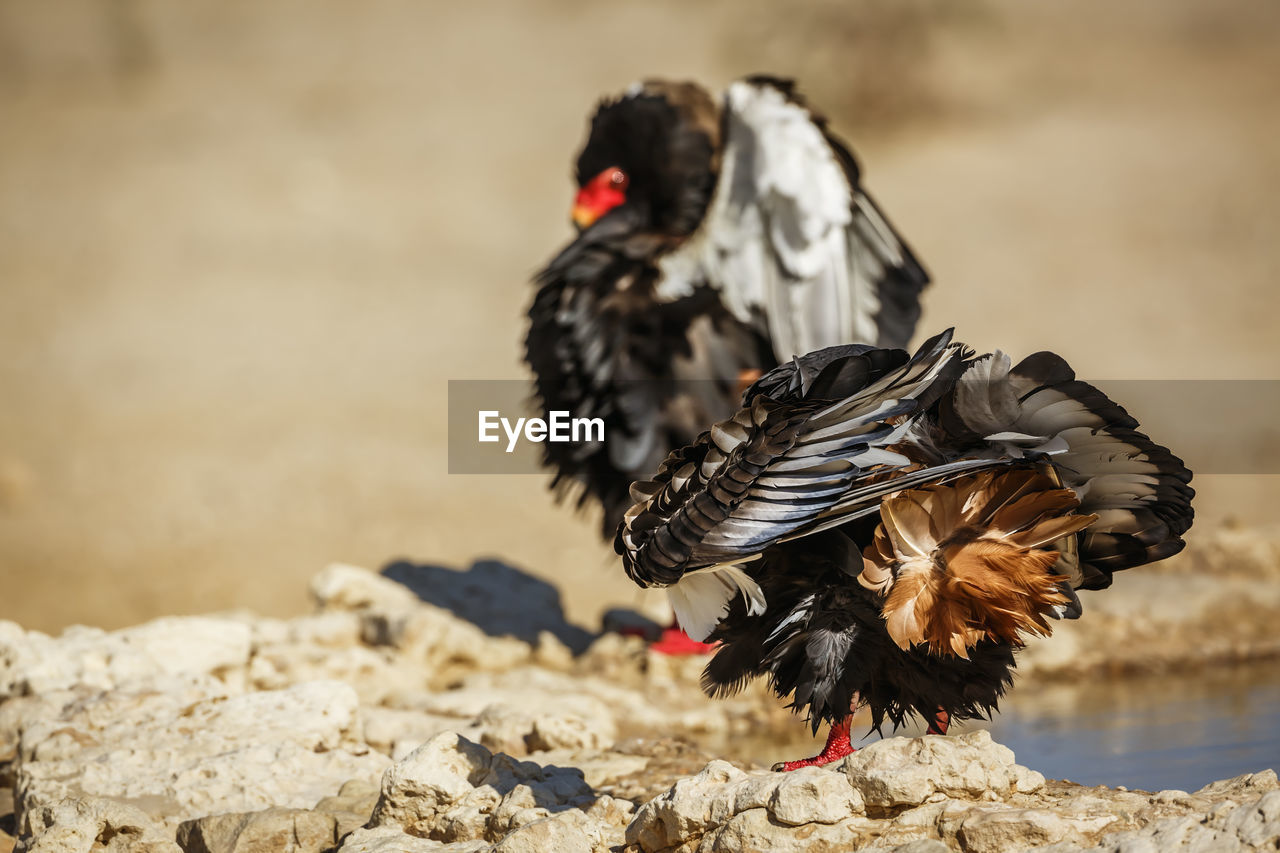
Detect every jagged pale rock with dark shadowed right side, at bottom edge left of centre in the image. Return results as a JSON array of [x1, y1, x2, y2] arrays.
[[369, 733, 630, 843]]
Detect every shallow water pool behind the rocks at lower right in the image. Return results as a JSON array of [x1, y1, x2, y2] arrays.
[[709, 661, 1280, 792]]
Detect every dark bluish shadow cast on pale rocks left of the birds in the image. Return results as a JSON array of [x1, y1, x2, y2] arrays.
[[381, 560, 595, 654]]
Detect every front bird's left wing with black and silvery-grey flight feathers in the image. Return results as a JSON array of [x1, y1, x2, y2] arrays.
[[614, 333, 972, 585]]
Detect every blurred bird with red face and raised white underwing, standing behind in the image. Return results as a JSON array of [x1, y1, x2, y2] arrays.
[[525, 77, 928, 538]]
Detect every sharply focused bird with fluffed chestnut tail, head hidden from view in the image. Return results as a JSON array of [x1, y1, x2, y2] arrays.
[[614, 330, 1194, 770]]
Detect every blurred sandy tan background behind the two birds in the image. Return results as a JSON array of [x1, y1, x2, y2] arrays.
[[0, 0, 1280, 629]]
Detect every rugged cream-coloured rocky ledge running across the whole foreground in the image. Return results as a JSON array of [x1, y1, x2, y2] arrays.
[[0, 532, 1280, 853]]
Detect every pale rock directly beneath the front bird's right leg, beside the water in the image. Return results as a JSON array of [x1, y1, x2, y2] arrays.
[[842, 730, 1044, 808]]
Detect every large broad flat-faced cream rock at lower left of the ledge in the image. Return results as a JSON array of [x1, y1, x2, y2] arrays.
[[17, 681, 389, 838]]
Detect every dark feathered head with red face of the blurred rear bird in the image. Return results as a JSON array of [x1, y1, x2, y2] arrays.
[[572, 81, 721, 237]]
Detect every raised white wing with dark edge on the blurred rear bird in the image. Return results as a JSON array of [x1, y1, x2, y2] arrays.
[[666, 77, 928, 350]]
